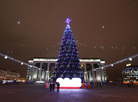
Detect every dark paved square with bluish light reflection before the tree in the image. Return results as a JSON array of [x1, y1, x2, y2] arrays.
[[0, 84, 138, 102]]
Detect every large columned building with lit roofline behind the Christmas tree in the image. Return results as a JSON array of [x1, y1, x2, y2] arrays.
[[26, 58, 106, 82]]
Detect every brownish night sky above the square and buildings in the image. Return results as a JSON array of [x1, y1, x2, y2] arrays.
[[0, 0, 138, 80]]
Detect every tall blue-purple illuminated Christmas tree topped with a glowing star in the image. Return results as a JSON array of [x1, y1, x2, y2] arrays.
[[53, 18, 83, 81]]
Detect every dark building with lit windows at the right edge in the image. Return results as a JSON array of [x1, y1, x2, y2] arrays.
[[122, 65, 138, 84]]
